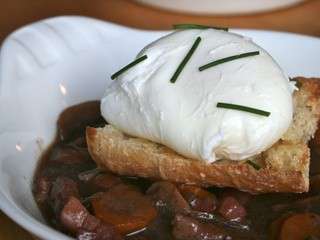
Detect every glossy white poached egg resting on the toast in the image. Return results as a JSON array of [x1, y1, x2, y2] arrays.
[[101, 29, 294, 162]]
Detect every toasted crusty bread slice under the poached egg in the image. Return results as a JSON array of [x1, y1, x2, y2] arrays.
[[87, 78, 320, 193]]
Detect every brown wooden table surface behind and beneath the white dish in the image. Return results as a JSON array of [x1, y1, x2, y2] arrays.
[[0, 0, 320, 240]]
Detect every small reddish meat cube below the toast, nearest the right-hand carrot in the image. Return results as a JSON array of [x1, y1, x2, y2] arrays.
[[218, 196, 247, 221]]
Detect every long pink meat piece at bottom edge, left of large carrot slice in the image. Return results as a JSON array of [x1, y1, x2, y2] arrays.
[[60, 197, 122, 240]]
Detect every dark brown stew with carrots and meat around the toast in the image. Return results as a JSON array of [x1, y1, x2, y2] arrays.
[[33, 102, 320, 240]]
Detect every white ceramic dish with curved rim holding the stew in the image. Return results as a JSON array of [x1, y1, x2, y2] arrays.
[[0, 17, 320, 240]]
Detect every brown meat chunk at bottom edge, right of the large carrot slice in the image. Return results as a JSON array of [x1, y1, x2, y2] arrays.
[[173, 214, 232, 240]]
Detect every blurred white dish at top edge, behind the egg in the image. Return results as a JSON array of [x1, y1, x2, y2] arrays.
[[136, 0, 304, 15]]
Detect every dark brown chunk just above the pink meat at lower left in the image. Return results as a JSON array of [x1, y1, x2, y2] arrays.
[[50, 177, 79, 215]]
